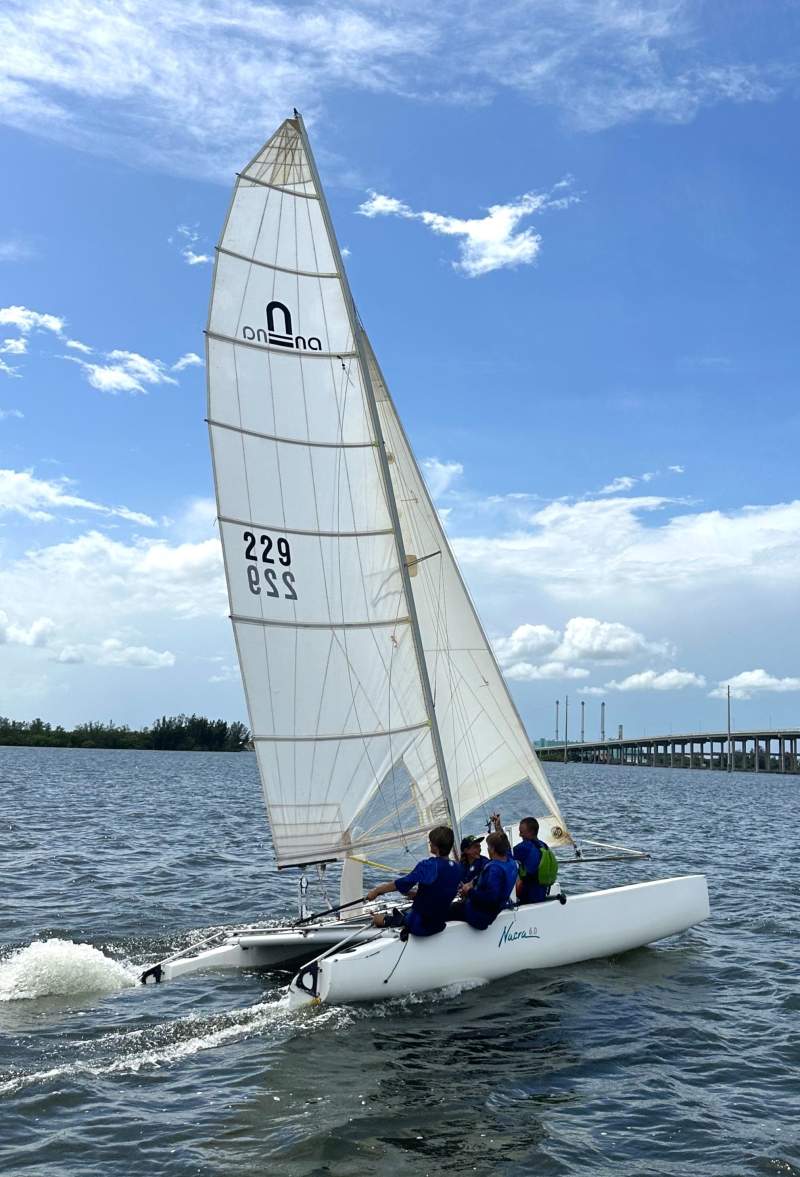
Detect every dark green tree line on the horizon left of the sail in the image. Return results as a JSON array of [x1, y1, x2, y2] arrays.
[[0, 716, 251, 752]]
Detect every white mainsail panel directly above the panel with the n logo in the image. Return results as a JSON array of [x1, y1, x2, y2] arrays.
[[220, 182, 336, 274]]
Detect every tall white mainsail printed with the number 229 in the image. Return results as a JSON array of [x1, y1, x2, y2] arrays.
[[207, 120, 447, 865]]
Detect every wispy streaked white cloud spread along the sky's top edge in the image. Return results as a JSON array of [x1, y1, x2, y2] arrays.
[[0, 0, 781, 174]]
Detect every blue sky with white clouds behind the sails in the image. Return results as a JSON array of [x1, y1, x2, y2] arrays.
[[0, 0, 800, 738]]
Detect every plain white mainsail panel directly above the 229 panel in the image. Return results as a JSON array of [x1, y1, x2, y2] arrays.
[[211, 425, 392, 533]]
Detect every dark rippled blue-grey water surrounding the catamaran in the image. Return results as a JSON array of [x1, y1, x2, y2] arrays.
[[0, 749, 800, 1177]]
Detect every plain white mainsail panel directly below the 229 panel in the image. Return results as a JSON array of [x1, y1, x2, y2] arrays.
[[234, 621, 426, 745]]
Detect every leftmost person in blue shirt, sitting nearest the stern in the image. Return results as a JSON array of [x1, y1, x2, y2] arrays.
[[367, 825, 461, 936]]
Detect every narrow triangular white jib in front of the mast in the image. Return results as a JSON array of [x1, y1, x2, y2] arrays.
[[367, 345, 572, 845]]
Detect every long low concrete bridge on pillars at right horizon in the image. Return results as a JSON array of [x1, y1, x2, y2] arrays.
[[536, 727, 800, 773]]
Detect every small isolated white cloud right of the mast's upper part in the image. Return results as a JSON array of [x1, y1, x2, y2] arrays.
[[356, 181, 579, 278]]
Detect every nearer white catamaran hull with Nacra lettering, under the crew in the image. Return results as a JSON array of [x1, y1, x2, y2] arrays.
[[289, 875, 709, 1005]]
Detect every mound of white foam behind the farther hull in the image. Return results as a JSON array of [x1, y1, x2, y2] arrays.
[[0, 938, 138, 1002]]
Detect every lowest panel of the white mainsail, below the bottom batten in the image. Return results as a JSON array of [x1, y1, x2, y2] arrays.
[[255, 733, 433, 865]]
